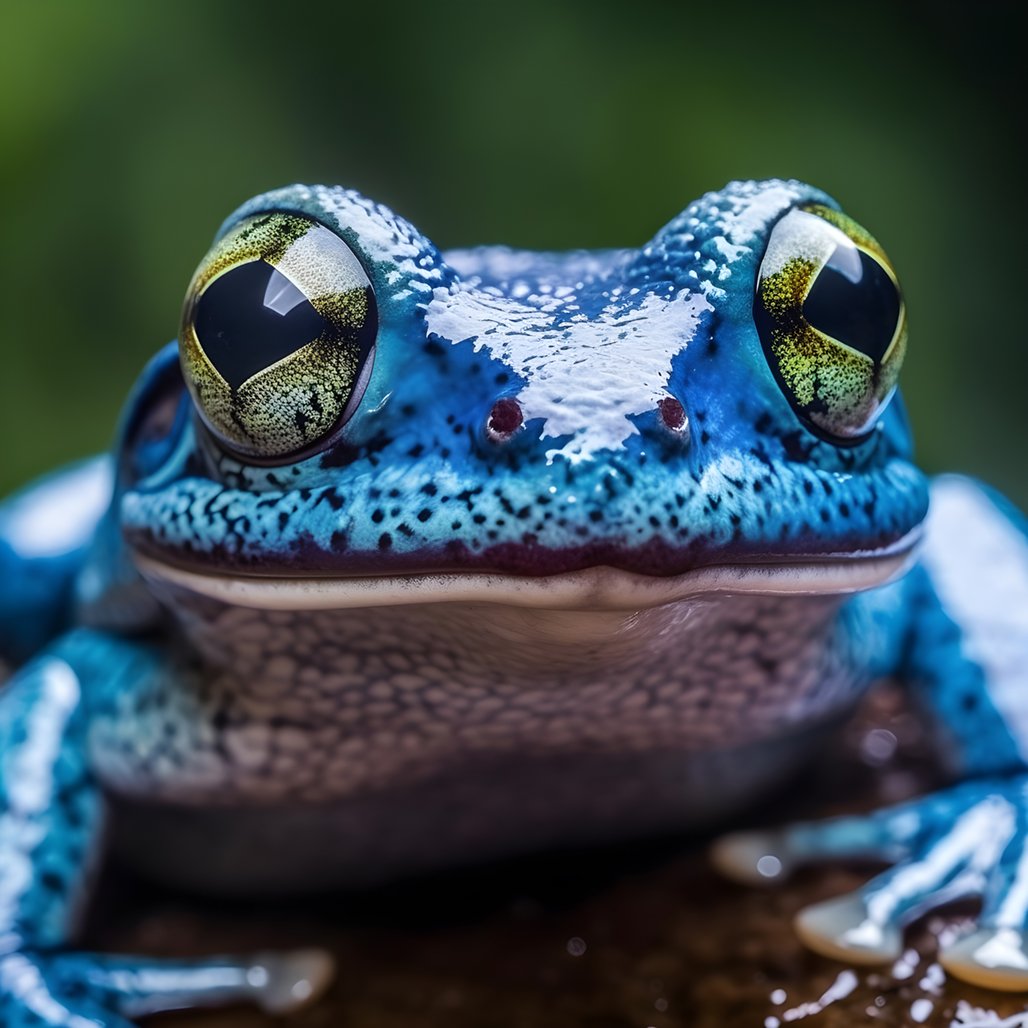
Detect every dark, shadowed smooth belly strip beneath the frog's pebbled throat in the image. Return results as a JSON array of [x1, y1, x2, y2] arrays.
[[113, 733, 826, 895]]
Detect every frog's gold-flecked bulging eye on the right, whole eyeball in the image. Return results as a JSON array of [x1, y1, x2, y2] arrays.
[[754, 205, 907, 442]]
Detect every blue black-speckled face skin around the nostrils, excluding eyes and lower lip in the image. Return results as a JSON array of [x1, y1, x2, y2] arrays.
[[121, 183, 927, 575]]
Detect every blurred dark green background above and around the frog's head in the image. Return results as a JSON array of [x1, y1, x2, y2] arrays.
[[0, 0, 1028, 506]]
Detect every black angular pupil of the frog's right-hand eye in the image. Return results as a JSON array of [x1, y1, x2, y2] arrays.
[[803, 247, 900, 363]]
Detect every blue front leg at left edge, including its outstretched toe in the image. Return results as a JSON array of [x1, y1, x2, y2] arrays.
[[0, 632, 331, 1028]]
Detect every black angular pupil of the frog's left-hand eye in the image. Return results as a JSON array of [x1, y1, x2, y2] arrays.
[[193, 260, 330, 389]]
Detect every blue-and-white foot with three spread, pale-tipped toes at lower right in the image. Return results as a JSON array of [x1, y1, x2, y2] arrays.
[[712, 778, 1028, 991]]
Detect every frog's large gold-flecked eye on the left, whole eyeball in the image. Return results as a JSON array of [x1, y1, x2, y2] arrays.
[[179, 214, 378, 461]]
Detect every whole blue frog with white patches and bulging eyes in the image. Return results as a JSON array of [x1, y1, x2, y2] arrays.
[[0, 179, 1028, 1028]]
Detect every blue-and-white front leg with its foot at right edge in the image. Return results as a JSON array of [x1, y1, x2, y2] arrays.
[[713, 477, 1028, 991]]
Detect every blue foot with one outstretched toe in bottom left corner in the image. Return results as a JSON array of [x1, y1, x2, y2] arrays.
[[0, 950, 333, 1028]]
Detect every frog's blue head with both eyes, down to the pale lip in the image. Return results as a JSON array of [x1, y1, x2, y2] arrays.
[[110, 181, 927, 608]]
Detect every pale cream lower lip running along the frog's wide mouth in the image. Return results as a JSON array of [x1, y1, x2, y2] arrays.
[[134, 528, 921, 611]]
